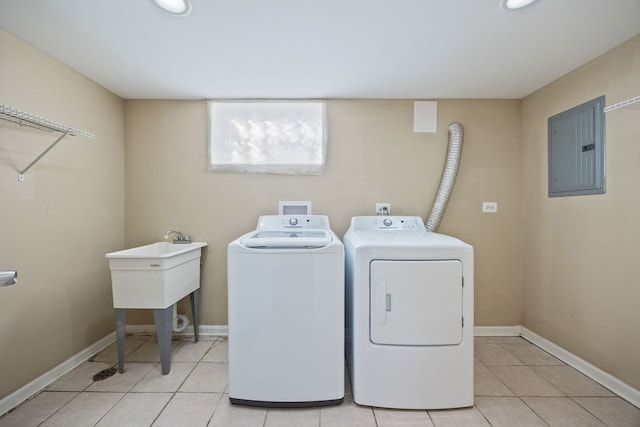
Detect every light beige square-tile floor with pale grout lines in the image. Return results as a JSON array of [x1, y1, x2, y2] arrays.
[[0, 335, 640, 427]]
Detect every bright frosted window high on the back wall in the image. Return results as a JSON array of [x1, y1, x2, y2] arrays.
[[208, 101, 326, 175]]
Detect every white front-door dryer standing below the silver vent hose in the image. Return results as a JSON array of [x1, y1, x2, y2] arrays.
[[343, 216, 473, 409]]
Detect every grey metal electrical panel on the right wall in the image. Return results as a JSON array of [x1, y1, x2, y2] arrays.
[[548, 96, 606, 197]]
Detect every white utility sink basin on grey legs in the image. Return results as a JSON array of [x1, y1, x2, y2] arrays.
[[106, 242, 207, 308]]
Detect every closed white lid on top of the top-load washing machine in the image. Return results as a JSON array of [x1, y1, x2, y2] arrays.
[[242, 229, 333, 248]]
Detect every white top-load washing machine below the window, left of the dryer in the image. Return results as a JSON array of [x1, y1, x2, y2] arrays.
[[228, 215, 345, 407]]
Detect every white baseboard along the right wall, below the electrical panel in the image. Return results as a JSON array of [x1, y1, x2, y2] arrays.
[[521, 327, 640, 408]]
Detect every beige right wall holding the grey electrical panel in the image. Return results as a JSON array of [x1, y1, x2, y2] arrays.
[[522, 37, 640, 389]]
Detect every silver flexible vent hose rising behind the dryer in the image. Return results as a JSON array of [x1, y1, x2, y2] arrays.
[[425, 122, 464, 232]]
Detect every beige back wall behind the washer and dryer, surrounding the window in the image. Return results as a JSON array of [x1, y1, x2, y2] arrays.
[[125, 100, 522, 325]]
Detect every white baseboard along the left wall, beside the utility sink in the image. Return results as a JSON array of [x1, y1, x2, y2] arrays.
[[0, 332, 116, 416]]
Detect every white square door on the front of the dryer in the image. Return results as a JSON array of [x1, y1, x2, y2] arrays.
[[369, 260, 463, 346]]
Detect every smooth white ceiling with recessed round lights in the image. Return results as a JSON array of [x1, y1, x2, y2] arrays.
[[0, 0, 640, 99]]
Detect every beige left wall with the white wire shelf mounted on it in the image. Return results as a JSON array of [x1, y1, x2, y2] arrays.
[[0, 30, 124, 398]]
